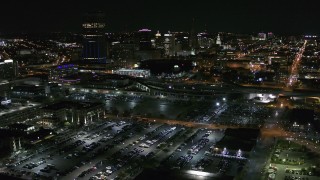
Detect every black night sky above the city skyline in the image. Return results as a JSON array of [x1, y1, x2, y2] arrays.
[[0, 0, 320, 33]]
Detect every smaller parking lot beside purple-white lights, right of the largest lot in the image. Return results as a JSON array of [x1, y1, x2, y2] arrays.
[[162, 129, 246, 176]]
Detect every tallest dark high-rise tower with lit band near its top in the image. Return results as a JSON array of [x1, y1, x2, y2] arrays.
[[82, 12, 107, 64]]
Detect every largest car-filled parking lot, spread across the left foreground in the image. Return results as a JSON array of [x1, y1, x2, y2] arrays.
[[0, 116, 200, 179]]
